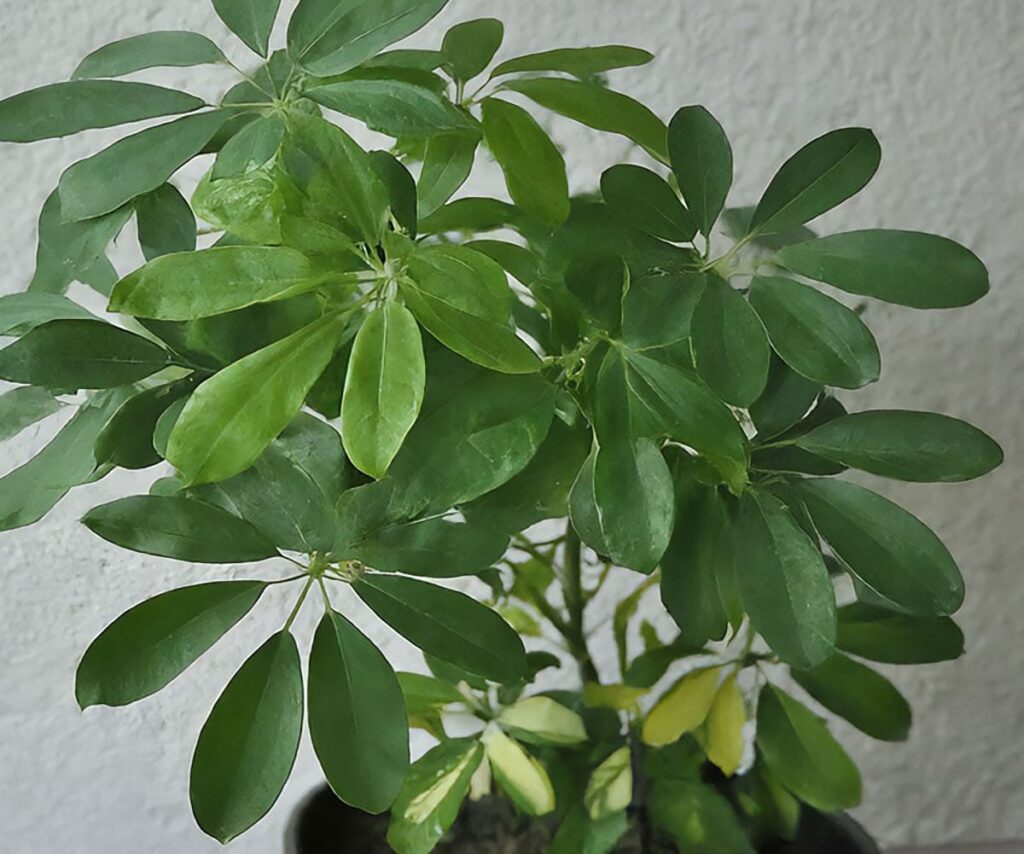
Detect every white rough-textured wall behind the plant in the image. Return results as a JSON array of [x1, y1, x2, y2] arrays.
[[0, 0, 1024, 854]]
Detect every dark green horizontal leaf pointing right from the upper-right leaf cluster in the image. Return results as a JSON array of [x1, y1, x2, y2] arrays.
[[775, 228, 988, 308]]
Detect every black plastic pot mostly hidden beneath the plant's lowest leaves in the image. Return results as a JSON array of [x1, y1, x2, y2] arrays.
[[285, 785, 881, 854]]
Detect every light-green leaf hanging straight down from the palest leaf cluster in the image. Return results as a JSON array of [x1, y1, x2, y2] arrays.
[[341, 300, 426, 478]]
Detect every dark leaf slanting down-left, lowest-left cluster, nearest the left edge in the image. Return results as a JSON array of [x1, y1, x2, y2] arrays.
[[75, 582, 266, 709]]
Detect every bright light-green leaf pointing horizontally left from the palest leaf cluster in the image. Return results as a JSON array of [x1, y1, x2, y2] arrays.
[[108, 246, 327, 321]]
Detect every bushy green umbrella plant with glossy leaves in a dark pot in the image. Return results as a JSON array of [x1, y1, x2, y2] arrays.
[[0, 0, 1001, 854]]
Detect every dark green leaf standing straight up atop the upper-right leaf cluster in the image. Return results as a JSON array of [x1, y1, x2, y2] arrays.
[[669, 105, 732, 238]]
